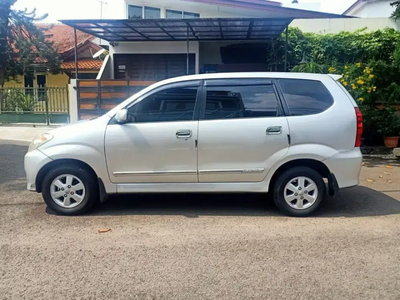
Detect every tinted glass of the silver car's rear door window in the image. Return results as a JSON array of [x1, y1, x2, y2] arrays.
[[205, 85, 278, 120]]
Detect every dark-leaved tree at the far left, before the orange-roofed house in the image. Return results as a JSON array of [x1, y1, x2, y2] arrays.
[[0, 0, 61, 86]]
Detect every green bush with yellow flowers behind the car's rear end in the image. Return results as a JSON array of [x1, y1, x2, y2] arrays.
[[282, 28, 400, 144]]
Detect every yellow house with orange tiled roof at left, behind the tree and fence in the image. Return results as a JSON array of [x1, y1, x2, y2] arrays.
[[4, 24, 103, 87]]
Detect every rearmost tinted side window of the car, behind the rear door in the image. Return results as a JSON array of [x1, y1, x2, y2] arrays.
[[278, 79, 333, 116]]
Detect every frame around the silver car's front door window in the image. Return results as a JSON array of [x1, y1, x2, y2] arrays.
[[109, 80, 203, 125]]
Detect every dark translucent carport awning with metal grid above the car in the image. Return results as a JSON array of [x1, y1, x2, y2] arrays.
[[61, 18, 293, 42]]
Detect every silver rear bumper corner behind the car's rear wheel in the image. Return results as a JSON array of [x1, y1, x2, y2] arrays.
[[324, 148, 362, 189]]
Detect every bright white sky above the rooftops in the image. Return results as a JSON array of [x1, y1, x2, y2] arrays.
[[14, 0, 355, 22]]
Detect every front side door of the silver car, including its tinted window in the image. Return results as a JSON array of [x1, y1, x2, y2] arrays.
[[105, 81, 200, 183]]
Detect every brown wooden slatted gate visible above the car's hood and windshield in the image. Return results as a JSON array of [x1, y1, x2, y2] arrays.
[[77, 79, 155, 120]]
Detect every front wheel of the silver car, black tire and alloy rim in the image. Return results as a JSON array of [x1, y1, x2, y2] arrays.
[[42, 164, 98, 216]]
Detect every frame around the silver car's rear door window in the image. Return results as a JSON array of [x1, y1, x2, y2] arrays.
[[199, 78, 286, 121]]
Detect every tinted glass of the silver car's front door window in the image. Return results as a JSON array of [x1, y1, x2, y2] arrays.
[[128, 87, 197, 123]]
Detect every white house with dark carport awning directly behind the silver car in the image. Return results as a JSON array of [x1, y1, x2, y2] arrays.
[[62, 0, 341, 82]]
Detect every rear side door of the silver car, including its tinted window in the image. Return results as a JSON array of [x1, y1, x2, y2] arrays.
[[198, 79, 290, 182]]
